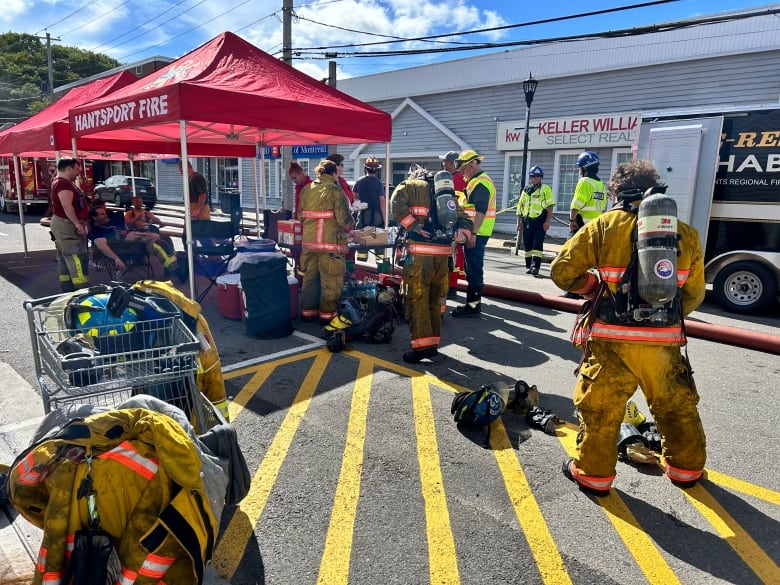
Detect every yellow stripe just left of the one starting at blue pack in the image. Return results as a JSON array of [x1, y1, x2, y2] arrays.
[[411, 375, 460, 585]]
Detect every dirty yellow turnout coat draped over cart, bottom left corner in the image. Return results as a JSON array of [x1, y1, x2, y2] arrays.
[[9, 409, 224, 585]]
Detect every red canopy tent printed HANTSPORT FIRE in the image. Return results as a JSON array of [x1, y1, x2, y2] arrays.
[[70, 32, 392, 296]]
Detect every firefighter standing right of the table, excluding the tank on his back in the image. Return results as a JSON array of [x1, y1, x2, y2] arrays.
[[390, 167, 474, 364]]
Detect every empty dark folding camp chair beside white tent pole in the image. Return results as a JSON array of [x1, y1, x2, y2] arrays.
[[192, 219, 238, 302]]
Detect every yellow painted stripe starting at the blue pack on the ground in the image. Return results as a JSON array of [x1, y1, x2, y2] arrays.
[[490, 419, 572, 585]]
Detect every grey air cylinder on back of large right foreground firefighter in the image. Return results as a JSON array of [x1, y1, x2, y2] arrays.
[[637, 193, 677, 307]]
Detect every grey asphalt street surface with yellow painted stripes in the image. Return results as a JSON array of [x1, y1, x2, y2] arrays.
[[0, 210, 780, 585]]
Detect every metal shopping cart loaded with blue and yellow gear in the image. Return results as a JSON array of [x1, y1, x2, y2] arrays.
[[24, 286, 224, 434]]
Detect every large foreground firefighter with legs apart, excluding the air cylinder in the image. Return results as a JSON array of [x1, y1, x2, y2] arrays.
[[550, 161, 706, 496]]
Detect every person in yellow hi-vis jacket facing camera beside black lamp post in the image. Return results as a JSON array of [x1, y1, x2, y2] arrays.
[[517, 166, 555, 276]]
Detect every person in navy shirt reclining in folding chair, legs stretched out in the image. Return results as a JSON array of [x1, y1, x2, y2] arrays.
[[89, 207, 187, 282]]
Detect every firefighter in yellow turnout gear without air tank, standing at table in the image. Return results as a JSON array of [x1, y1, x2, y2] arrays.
[[297, 160, 352, 324]]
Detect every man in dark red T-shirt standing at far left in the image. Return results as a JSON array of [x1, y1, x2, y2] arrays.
[[51, 157, 89, 292]]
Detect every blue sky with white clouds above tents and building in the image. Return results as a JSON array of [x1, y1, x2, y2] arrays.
[[0, 0, 780, 79]]
